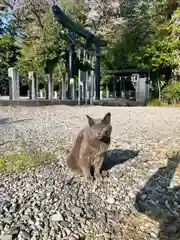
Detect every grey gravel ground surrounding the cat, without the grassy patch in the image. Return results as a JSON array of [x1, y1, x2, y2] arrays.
[[0, 106, 180, 240]]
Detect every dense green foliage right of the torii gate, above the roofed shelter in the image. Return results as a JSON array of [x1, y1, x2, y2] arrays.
[[103, 0, 180, 86]]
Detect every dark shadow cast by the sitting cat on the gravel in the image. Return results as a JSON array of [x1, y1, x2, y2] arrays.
[[102, 148, 140, 171]]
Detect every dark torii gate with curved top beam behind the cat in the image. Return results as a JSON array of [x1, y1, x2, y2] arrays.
[[52, 5, 107, 100]]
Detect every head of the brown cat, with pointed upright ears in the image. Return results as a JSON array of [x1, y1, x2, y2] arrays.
[[86, 113, 112, 143]]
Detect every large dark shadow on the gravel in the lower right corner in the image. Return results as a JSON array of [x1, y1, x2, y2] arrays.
[[135, 152, 180, 240]]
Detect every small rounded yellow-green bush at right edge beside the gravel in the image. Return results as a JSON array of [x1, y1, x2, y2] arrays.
[[162, 81, 180, 104]]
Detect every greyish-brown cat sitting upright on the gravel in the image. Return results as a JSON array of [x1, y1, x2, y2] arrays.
[[66, 113, 112, 181]]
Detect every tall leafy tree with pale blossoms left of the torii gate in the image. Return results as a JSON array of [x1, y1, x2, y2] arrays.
[[3, 0, 68, 85]]
